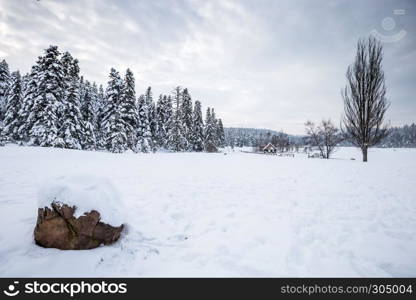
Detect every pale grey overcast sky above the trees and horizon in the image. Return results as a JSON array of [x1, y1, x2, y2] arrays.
[[0, 0, 416, 134]]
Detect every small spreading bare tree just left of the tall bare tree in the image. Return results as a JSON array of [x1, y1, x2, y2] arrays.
[[305, 119, 343, 159]]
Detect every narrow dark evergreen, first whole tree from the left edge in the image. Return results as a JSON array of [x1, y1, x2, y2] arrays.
[[3, 71, 22, 141]]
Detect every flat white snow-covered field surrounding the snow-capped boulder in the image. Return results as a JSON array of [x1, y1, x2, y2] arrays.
[[0, 146, 416, 277]]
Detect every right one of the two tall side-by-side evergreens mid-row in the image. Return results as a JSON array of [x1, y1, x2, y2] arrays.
[[120, 69, 139, 150]]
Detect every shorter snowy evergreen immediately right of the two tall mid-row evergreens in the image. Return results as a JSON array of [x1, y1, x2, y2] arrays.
[[136, 95, 152, 153]]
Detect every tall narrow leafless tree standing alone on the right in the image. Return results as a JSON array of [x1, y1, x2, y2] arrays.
[[341, 37, 390, 162]]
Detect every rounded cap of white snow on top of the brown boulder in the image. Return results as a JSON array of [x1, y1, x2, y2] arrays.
[[38, 175, 126, 226]]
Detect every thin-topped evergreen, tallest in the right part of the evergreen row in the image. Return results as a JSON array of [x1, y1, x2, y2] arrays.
[[168, 86, 187, 151]]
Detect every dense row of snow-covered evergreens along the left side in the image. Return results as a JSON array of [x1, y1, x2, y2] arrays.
[[0, 46, 225, 153]]
